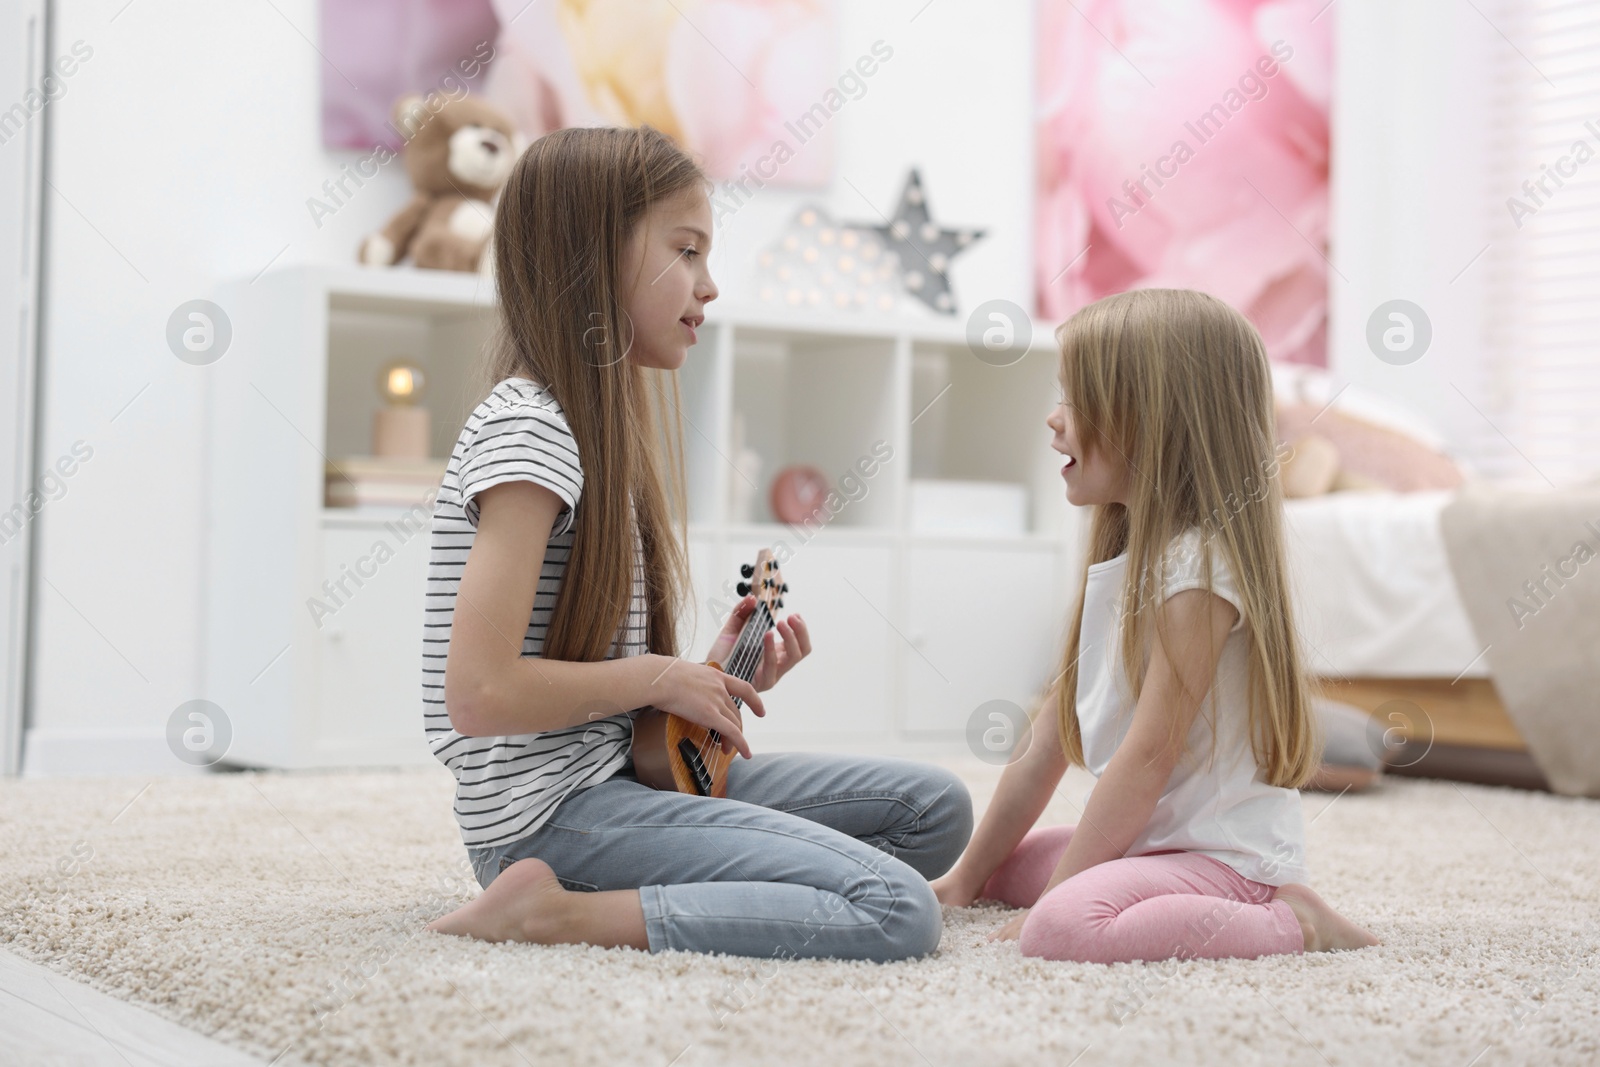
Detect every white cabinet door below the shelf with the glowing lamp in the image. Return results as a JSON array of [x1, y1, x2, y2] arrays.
[[307, 523, 434, 766]]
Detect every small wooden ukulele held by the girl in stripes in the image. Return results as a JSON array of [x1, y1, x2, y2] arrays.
[[634, 549, 789, 797]]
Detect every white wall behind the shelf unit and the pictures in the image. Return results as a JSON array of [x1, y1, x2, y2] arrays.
[[27, 0, 1506, 773]]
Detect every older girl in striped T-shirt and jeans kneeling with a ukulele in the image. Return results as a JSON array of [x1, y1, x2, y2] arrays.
[[422, 128, 971, 960]]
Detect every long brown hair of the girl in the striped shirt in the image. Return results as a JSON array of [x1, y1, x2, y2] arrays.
[[482, 126, 709, 661]]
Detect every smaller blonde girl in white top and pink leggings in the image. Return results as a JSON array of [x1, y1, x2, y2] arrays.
[[934, 290, 1378, 963]]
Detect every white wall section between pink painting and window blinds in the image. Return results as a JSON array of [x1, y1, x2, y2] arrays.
[[1328, 0, 1514, 463]]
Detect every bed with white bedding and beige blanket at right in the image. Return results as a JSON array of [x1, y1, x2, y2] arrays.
[[1272, 363, 1600, 797]]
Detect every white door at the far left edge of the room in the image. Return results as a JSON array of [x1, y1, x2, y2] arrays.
[[0, 0, 50, 776]]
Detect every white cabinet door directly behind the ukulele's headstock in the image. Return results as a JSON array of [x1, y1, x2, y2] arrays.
[[726, 528, 901, 749]]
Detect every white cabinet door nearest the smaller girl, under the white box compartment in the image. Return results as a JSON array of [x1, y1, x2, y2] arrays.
[[902, 542, 1070, 734]]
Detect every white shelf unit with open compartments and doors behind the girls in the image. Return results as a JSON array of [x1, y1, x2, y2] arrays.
[[205, 266, 1078, 766]]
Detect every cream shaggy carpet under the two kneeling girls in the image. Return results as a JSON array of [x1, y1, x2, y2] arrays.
[[0, 763, 1600, 1067]]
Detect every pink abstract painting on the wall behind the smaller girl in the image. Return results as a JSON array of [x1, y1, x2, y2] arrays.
[[1034, 0, 1336, 366]]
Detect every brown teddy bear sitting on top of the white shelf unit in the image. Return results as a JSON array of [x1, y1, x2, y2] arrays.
[[357, 94, 523, 272]]
